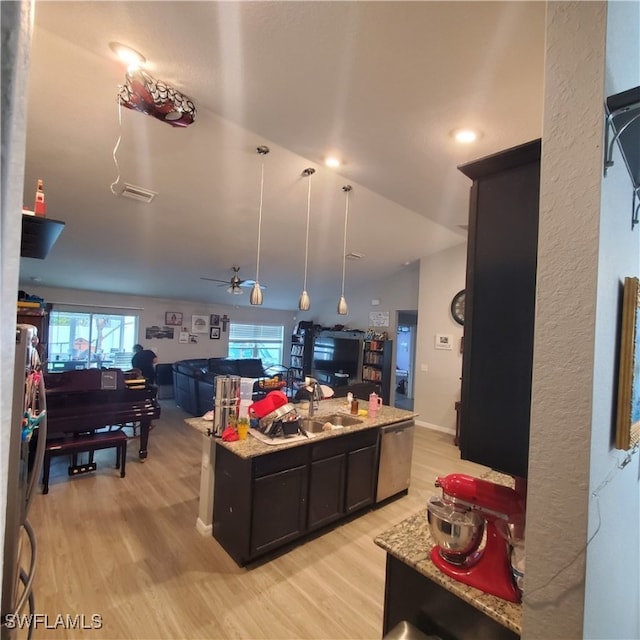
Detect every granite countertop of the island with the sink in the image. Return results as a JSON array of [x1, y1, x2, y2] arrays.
[[185, 398, 418, 458]]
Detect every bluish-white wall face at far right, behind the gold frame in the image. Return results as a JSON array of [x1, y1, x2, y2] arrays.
[[584, 2, 640, 640]]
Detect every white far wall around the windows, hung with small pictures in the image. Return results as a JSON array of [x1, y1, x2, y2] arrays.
[[28, 284, 295, 365]]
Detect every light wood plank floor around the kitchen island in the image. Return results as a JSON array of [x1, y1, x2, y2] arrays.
[[30, 400, 486, 640]]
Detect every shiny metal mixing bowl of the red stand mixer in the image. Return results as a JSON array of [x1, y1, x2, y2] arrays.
[[427, 496, 484, 564]]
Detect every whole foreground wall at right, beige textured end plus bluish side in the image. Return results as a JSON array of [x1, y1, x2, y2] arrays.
[[523, 2, 640, 640]]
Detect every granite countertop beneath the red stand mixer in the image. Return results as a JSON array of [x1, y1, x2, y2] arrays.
[[374, 472, 522, 635]]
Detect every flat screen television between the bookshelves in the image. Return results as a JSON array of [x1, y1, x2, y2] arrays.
[[312, 336, 362, 386]]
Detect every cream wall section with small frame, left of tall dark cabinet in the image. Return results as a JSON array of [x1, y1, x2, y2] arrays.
[[414, 242, 464, 432]]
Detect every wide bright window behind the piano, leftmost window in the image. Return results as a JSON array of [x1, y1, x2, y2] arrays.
[[47, 311, 138, 372]]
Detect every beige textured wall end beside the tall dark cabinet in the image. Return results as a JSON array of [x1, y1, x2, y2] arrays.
[[523, 2, 606, 640]]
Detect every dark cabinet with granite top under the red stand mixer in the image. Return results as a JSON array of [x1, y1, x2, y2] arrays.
[[374, 478, 522, 640]]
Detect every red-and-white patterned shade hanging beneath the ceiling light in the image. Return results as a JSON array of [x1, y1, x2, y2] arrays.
[[118, 69, 196, 127]]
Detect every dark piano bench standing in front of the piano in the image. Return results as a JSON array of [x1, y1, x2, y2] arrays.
[[42, 429, 128, 494]]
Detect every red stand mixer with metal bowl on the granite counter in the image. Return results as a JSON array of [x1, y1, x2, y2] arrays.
[[427, 473, 524, 602]]
